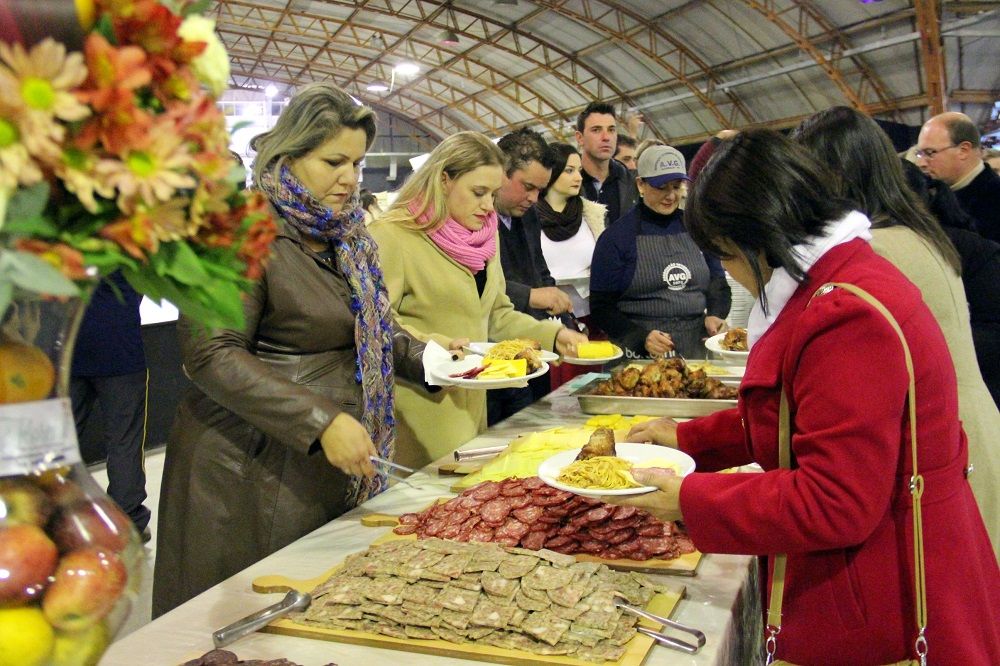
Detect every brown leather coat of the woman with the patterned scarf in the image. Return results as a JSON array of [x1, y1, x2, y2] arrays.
[[153, 216, 424, 616]]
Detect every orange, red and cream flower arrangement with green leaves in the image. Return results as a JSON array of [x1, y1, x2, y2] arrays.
[[0, 0, 276, 328]]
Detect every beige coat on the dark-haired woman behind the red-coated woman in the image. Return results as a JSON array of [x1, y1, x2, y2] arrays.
[[872, 227, 1000, 552]]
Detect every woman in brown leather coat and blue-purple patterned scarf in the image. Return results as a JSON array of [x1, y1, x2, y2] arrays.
[[153, 84, 434, 616]]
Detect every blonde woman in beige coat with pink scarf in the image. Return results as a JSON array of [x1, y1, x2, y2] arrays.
[[371, 132, 586, 467]]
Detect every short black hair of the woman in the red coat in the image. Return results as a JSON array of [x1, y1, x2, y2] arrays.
[[684, 129, 852, 312]]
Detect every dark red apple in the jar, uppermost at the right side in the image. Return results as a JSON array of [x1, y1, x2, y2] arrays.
[[52, 498, 132, 553]]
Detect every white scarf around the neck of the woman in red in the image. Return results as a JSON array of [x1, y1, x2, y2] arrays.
[[747, 210, 872, 347]]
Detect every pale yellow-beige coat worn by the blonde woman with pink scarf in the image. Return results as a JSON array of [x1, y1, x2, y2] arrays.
[[370, 221, 561, 467]]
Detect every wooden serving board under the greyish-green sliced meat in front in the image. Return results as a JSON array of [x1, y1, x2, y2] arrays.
[[253, 565, 684, 666]]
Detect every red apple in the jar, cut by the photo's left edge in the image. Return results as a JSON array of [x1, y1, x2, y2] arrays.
[[0, 525, 59, 604]]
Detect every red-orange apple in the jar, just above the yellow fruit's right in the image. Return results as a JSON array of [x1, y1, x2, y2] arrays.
[[42, 548, 128, 631]]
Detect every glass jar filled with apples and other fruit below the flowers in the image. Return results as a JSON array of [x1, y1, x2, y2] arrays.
[[0, 294, 144, 666]]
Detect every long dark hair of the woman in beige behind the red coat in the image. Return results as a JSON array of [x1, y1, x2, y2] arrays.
[[792, 106, 962, 272]]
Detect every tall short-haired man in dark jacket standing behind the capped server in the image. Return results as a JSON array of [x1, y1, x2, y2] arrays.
[[576, 102, 639, 226]]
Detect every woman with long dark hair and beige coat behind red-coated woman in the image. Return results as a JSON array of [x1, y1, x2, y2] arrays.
[[794, 107, 1000, 552]]
